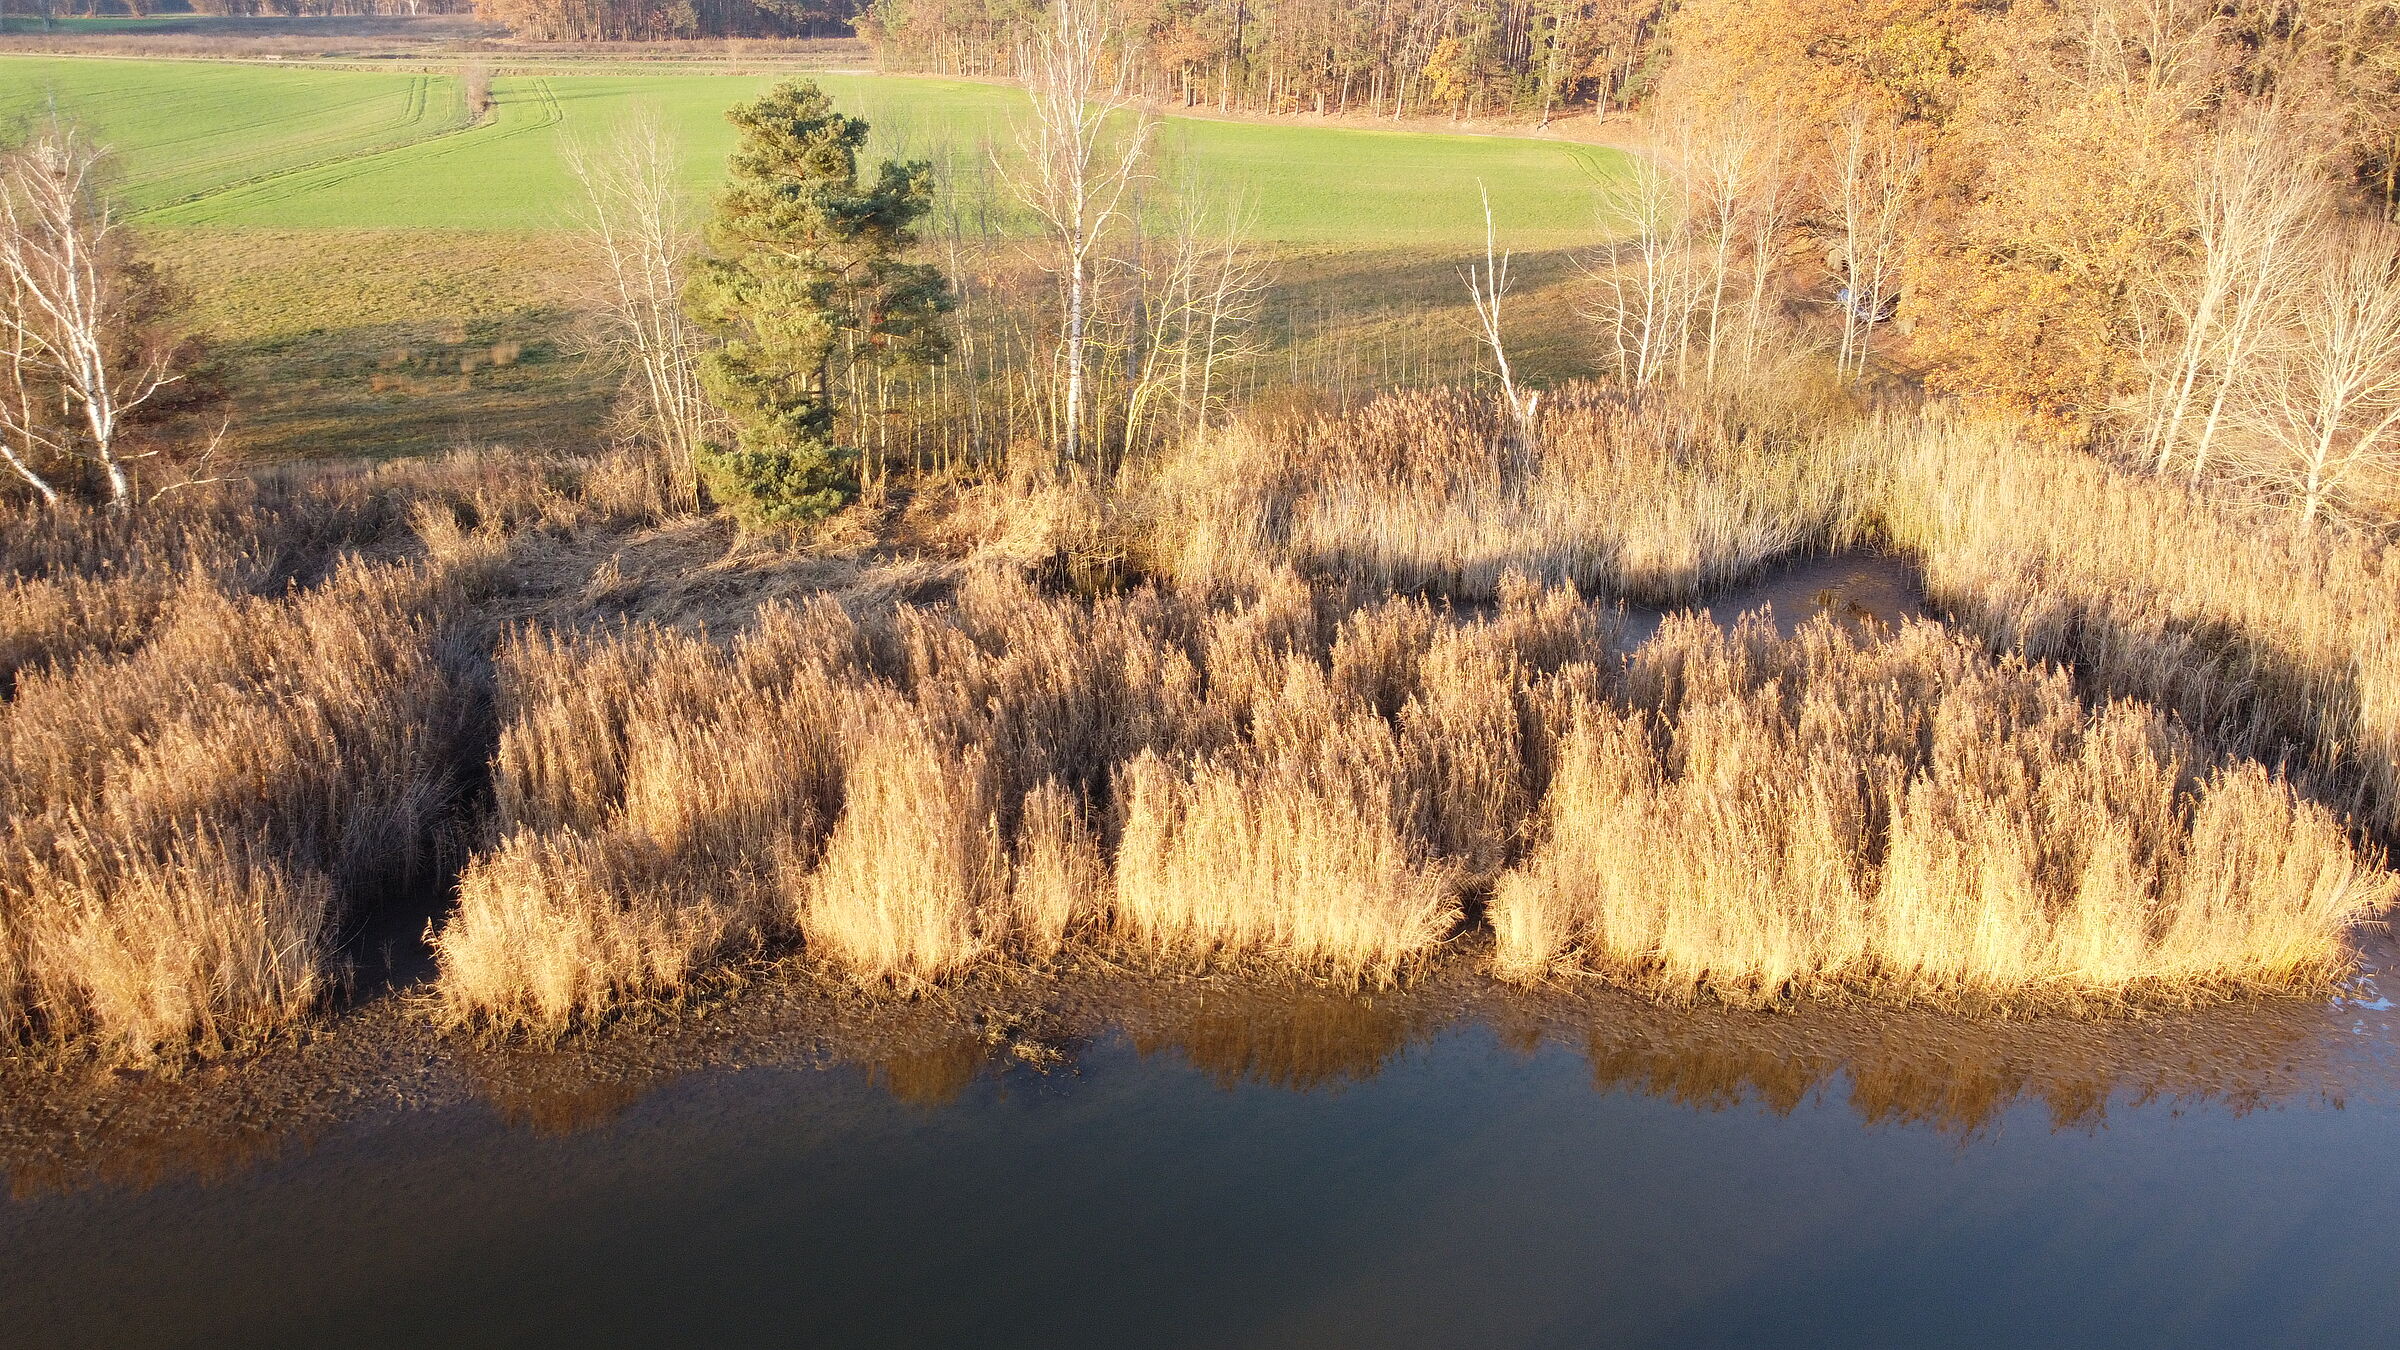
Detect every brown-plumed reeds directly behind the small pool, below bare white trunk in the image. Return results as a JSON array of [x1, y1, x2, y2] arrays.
[[1142, 387, 1850, 603]]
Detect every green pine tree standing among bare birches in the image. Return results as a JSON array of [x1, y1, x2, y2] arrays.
[[691, 82, 953, 524]]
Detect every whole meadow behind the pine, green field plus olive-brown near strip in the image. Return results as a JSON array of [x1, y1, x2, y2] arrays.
[[0, 55, 1618, 459]]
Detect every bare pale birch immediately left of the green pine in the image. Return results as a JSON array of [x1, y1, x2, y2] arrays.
[[564, 115, 708, 502]]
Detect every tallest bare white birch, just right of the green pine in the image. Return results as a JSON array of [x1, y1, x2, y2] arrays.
[[1001, 0, 1154, 471]]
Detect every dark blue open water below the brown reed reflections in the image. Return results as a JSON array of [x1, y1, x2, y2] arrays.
[[0, 975, 2400, 1348]]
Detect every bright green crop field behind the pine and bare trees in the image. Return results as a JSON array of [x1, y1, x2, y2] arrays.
[[0, 58, 1615, 247]]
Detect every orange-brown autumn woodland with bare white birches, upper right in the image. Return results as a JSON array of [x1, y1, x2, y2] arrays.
[[1598, 0, 2400, 519]]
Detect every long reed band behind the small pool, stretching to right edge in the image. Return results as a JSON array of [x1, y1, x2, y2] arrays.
[[1128, 387, 2400, 836]]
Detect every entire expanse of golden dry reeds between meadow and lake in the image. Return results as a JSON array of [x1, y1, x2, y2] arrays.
[[0, 389, 2400, 1059]]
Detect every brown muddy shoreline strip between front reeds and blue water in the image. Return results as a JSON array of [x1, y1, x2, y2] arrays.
[[0, 932, 2395, 1201]]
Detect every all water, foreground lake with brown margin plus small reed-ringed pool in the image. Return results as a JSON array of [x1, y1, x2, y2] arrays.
[[0, 557, 2400, 1350]]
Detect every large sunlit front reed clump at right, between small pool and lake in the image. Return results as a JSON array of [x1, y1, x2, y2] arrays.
[[1490, 617, 2395, 1002]]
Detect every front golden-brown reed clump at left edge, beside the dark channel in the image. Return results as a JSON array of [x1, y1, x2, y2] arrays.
[[0, 565, 463, 1062]]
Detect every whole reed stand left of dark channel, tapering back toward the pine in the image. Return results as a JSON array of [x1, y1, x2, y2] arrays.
[[0, 454, 696, 1062]]
